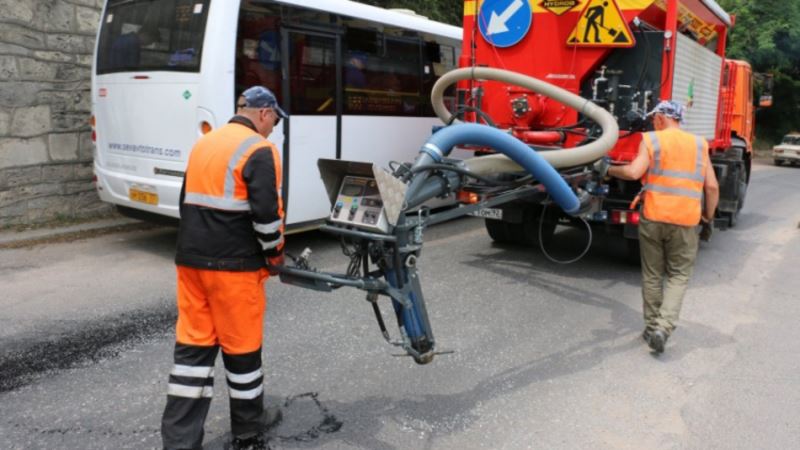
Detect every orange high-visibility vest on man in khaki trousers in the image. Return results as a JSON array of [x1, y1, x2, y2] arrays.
[[642, 128, 708, 226]]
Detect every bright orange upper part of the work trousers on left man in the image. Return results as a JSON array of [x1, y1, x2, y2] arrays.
[[175, 266, 269, 355]]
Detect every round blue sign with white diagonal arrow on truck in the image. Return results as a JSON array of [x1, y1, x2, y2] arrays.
[[478, 0, 533, 47]]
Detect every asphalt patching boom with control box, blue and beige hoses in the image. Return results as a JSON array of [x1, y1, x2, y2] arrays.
[[279, 68, 619, 364]]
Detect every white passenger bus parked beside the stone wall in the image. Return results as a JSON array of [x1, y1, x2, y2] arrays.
[[92, 0, 461, 230]]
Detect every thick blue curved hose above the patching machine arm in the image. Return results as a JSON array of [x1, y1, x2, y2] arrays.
[[415, 123, 580, 214]]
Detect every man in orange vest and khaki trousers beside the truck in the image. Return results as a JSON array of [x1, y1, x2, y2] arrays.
[[595, 101, 719, 353]]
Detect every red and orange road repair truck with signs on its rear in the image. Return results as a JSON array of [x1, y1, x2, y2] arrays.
[[457, 0, 754, 255]]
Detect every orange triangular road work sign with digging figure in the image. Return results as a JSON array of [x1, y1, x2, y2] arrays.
[[567, 0, 636, 47]]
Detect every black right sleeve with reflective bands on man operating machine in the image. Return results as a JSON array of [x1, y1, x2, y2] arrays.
[[242, 147, 283, 258]]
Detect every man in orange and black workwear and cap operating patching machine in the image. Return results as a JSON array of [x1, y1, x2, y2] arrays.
[[161, 86, 288, 449]]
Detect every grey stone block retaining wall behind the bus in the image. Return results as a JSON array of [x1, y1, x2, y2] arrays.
[[0, 0, 111, 227]]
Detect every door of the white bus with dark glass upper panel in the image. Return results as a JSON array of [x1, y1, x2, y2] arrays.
[[281, 28, 341, 225]]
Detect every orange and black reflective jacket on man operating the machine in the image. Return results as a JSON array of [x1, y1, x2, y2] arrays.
[[175, 116, 284, 271]]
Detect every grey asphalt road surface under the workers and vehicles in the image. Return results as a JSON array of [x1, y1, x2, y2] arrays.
[[0, 160, 800, 449]]
